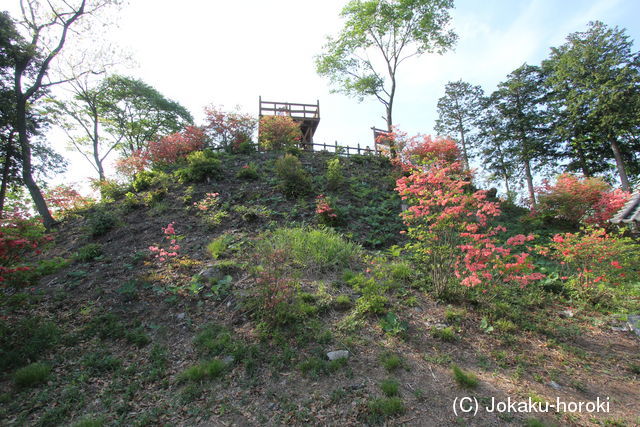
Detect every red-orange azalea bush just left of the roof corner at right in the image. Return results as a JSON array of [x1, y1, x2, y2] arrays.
[[535, 173, 631, 227]]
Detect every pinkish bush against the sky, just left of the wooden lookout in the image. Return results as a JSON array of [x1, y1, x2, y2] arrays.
[[204, 106, 256, 150]]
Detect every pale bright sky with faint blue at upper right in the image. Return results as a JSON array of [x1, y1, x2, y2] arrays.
[[3, 0, 640, 189]]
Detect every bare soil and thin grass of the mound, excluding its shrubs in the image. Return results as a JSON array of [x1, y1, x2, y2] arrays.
[[0, 155, 640, 425]]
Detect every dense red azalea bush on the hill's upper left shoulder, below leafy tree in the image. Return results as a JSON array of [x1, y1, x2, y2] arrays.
[[148, 126, 205, 164]]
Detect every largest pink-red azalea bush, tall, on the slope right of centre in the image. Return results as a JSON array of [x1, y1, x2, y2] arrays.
[[395, 134, 544, 295]]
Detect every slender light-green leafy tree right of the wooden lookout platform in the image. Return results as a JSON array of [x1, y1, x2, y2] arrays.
[[316, 0, 457, 154]]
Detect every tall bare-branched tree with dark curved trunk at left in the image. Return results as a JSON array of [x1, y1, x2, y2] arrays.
[[11, 0, 116, 228]]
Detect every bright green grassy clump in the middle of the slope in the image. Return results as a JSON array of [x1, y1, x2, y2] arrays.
[[258, 228, 361, 272]]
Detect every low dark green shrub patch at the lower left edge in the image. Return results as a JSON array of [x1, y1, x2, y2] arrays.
[[0, 317, 62, 372]]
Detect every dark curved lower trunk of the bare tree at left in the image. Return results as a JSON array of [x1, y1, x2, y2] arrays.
[[16, 93, 56, 230]]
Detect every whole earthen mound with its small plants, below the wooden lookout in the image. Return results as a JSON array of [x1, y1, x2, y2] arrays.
[[0, 152, 640, 426]]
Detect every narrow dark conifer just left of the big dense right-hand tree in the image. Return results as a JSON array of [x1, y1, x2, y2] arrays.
[[490, 64, 554, 207]]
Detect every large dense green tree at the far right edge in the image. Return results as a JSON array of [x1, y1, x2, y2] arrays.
[[543, 21, 640, 191]]
